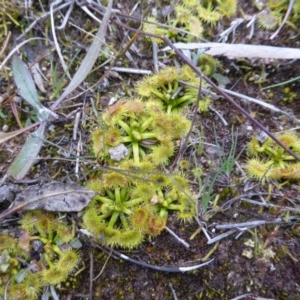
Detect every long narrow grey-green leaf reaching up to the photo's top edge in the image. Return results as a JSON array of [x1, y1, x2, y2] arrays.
[[50, 0, 112, 110]]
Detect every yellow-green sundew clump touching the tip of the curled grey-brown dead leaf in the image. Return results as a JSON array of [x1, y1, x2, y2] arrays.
[[83, 166, 195, 249]]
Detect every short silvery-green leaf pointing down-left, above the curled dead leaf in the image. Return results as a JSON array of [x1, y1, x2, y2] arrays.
[[7, 122, 46, 180]]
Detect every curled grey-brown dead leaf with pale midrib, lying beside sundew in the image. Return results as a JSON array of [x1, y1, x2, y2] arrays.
[[0, 181, 96, 219]]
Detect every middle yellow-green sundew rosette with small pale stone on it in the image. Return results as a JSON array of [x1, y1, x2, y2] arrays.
[[92, 99, 190, 165]]
